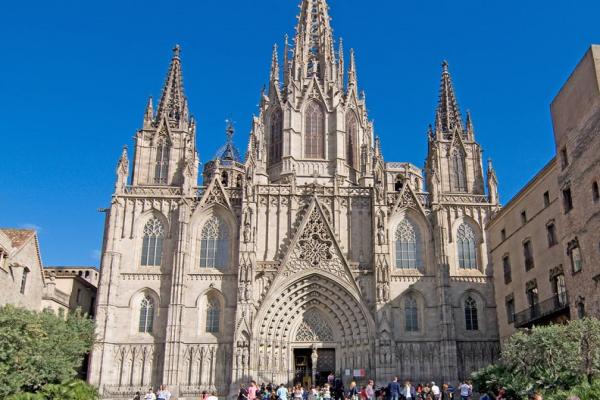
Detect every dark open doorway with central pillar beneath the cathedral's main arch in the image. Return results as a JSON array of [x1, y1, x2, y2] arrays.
[[294, 348, 335, 387]]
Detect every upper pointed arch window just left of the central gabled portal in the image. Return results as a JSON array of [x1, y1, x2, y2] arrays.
[[200, 216, 229, 268]]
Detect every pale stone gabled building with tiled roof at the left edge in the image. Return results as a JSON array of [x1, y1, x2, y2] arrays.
[[0, 228, 45, 311]]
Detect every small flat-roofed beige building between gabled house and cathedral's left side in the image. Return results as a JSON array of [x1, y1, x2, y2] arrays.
[[42, 267, 99, 318]]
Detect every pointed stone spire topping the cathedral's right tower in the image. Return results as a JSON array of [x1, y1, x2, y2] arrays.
[[435, 61, 463, 135]]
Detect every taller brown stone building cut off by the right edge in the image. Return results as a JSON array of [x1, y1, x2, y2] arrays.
[[551, 45, 600, 318]]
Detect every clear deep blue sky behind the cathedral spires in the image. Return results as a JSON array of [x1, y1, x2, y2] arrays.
[[0, 0, 600, 265]]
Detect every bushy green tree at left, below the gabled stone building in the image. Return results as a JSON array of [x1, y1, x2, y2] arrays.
[[0, 305, 94, 398]]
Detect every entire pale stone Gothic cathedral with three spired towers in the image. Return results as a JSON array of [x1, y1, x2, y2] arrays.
[[89, 0, 500, 399]]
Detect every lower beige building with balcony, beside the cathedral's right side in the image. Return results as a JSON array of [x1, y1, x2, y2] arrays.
[[487, 158, 569, 340]]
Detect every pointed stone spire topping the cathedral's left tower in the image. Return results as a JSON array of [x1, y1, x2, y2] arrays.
[[156, 45, 188, 126]]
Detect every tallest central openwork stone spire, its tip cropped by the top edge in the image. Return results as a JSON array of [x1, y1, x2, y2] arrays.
[[293, 0, 335, 80]]
